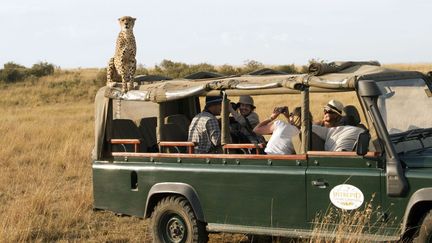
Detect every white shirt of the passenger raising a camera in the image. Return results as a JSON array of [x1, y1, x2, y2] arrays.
[[264, 120, 300, 154]]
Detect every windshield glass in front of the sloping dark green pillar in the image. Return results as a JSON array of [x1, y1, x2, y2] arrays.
[[377, 79, 432, 152]]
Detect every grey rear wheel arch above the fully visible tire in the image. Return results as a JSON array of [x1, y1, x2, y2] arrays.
[[144, 182, 205, 222]]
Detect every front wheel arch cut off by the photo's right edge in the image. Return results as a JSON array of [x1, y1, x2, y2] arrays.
[[402, 187, 432, 234]]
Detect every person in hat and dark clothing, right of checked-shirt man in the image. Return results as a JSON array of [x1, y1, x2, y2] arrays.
[[229, 95, 265, 143]]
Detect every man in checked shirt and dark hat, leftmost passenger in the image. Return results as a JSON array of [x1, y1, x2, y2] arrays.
[[188, 96, 222, 154]]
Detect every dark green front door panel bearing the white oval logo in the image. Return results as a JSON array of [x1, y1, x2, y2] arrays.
[[306, 151, 385, 231]]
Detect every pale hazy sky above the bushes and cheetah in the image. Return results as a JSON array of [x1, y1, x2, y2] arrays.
[[0, 0, 432, 68]]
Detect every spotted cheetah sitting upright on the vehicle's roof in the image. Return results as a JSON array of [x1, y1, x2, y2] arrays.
[[107, 16, 136, 93]]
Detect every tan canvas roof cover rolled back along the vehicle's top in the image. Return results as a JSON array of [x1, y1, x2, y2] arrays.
[[105, 61, 423, 103]]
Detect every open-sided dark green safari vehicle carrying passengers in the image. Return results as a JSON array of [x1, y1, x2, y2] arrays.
[[92, 62, 432, 242]]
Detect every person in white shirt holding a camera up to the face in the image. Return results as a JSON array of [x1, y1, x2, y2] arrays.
[[253, 106, 301, 154]]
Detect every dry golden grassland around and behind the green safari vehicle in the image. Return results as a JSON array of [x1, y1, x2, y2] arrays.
[[0, 64, 432, 242]]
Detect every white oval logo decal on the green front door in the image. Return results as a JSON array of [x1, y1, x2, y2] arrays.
[[330, 184, 364, 210]]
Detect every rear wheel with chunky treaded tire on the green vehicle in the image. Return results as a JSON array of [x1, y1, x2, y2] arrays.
[[151, 196, 208, 243]]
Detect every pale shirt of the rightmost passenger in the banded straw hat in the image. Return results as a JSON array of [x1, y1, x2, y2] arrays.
[[312, 125, 364, 151]]
